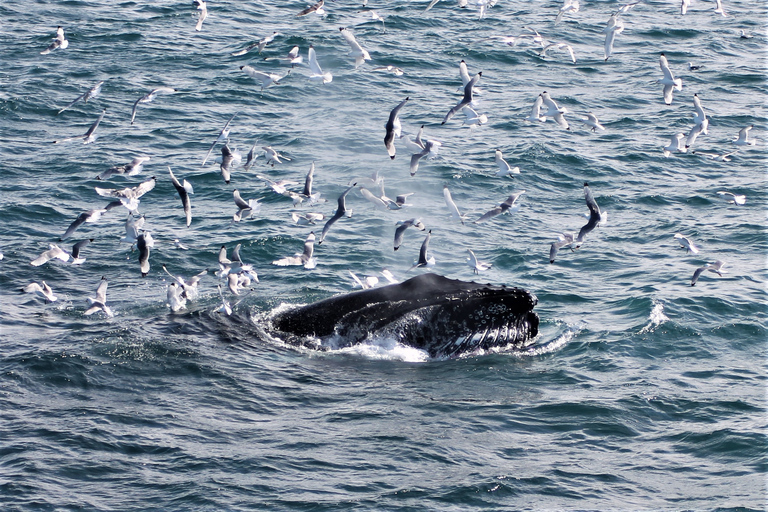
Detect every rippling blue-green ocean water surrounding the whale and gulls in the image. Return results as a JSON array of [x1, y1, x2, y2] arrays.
[[0, 0, 768, 511]]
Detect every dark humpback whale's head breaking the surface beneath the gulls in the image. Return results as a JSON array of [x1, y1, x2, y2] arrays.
[[272, 274, 539, 358]]
